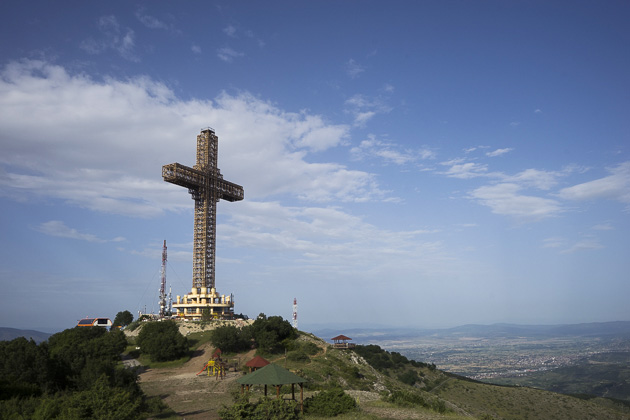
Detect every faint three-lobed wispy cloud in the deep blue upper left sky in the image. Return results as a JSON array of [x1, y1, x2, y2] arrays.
[[80, 15, 140, 61]]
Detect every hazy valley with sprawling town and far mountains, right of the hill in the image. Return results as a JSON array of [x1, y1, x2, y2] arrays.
[[320, 322, 630, 401]]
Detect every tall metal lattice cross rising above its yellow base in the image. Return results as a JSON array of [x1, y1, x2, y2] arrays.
[[162, 127, 244, 292]]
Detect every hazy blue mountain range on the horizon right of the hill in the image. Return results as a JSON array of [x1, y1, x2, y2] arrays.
[[312, 321, 630, 343]]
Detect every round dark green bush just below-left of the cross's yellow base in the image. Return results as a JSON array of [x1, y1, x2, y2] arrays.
[[136, 321, 188, 362]]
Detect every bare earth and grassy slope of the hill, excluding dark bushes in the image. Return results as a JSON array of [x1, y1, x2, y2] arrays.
[[127, 321, 629, 420]]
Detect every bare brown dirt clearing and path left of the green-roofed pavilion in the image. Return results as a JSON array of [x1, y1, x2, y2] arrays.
[[139, 343, 251, 419]]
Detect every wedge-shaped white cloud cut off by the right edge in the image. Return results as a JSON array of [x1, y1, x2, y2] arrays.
[[559, 162, 630, 203]]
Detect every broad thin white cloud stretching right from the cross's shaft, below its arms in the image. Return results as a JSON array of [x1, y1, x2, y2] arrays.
[[221, 201, 446, 276]]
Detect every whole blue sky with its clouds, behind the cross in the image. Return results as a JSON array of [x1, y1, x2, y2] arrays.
[[0, 0, 630, 331]]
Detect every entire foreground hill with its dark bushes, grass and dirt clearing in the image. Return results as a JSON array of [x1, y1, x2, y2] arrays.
[[0, 320, 630, 420]]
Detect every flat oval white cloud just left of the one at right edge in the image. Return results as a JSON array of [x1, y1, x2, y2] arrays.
[[470, 183, 562, 221]]
